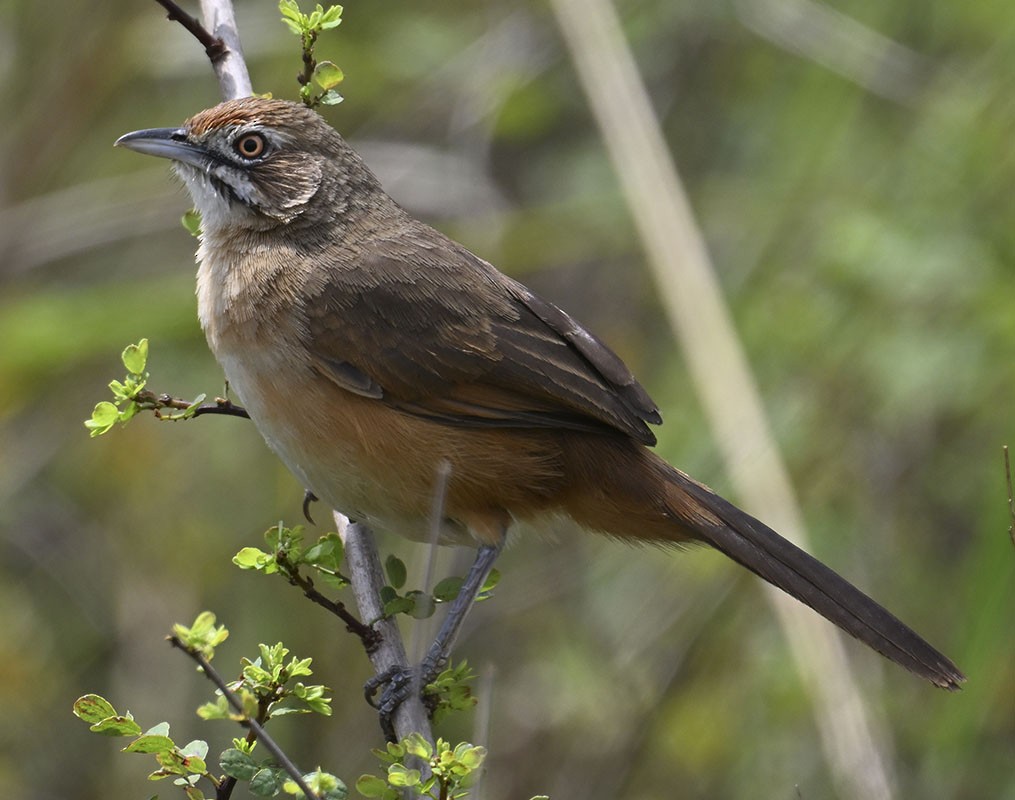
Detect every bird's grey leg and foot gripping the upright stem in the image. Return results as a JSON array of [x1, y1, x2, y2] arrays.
[[363, 542, 502, 741]]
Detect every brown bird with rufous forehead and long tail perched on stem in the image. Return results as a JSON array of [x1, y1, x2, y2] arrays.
[[117, 97, 964, 710]]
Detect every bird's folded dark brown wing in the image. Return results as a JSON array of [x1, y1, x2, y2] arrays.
[[307, 223, 662, 445]]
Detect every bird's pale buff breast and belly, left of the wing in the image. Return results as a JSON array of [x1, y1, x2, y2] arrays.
[[191, 237, 435, 535]]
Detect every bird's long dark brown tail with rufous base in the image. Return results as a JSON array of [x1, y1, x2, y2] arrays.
[[572, 440, 965, 689]]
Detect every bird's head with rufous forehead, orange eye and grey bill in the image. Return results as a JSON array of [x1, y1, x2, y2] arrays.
[[116, 97, 377, 230]]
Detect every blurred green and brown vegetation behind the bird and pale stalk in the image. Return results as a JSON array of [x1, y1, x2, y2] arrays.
[[0, 0, 1015, 800]]
